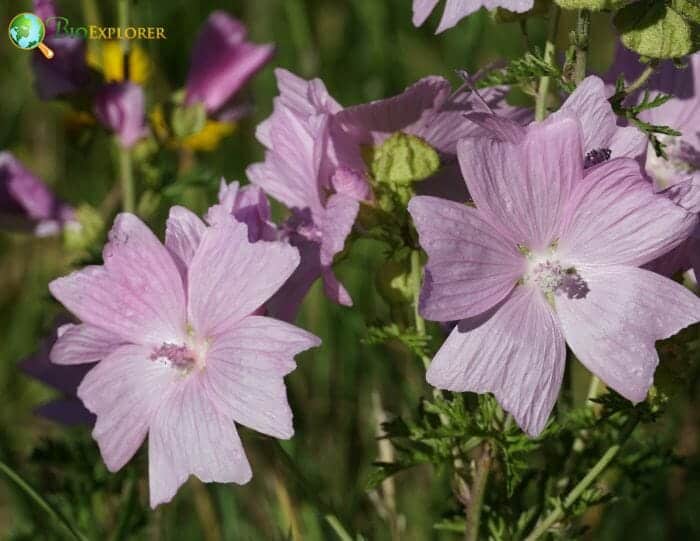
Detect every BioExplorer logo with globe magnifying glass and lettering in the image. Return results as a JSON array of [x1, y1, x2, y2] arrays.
[[7, 13, 167, 59]]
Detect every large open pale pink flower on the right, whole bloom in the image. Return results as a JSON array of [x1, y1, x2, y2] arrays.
[[409, 115, 700, 436]]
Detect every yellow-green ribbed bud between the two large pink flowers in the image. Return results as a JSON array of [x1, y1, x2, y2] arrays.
[[368, 132, 440, 186]]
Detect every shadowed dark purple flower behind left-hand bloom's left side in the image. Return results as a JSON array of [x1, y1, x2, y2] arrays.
[[20, 324, 95, 426]]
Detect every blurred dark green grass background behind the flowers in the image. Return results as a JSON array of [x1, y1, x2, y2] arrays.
[[0, 0, 700, 541]]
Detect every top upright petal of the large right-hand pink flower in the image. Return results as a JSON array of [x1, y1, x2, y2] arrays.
[[457, 116, 583, 251]]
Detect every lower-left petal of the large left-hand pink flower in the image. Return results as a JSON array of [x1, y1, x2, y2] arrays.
[[78, 345, 180, 472]]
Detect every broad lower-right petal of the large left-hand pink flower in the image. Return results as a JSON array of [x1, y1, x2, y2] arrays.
[[204, 316, 321, 439]]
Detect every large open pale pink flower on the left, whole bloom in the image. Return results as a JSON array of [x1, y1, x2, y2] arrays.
[[49, 207, 319, 507]]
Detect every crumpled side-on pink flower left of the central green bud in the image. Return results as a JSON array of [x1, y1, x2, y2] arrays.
[[247, 69, 369, 320]]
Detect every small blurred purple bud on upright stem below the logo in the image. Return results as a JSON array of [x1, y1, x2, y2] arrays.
[[94, 82, 147, 148]]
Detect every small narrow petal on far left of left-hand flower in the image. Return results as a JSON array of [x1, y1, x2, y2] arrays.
[[50, 324, 124, 364]]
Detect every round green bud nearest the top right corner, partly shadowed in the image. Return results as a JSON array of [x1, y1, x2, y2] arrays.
[[614, 0, 693, 58]]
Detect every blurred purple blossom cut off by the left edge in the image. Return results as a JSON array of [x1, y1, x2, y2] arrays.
[[0, 152, 78, 237]]
